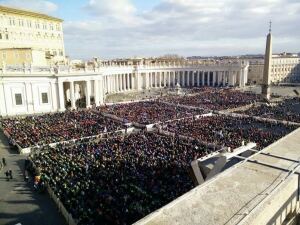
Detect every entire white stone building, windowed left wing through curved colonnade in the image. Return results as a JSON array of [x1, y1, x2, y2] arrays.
[[0, 61, 249, 116]]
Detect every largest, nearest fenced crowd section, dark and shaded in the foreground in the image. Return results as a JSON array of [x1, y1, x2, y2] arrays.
[[31, 132, 213, 225]]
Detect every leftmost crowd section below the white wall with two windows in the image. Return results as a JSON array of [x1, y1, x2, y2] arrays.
[[1, 110, 122, 148]]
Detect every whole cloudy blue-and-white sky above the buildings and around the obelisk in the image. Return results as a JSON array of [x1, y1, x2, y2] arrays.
[[0, 0, 300, 59]]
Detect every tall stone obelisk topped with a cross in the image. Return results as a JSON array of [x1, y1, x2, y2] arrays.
[[261, 22, 272, 100]]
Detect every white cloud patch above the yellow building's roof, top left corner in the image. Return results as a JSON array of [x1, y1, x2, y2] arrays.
[[0, 0, 58, 13]]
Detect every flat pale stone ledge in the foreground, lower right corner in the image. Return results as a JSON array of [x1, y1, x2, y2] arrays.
[[136, 128, 300, 225]]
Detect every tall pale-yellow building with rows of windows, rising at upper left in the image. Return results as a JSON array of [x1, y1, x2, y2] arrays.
[[0, 6, 65, 64]]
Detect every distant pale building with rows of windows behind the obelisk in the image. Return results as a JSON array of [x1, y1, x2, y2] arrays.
[[248, 55, 300, 84]]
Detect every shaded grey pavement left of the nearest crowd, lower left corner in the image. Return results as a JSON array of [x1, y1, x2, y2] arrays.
[[0, 132, 66, 225]]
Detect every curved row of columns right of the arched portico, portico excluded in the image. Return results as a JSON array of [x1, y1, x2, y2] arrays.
[[103, 70, 246, 94]]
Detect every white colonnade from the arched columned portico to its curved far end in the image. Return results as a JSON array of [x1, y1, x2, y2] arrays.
[[57, 67, 247, 111]]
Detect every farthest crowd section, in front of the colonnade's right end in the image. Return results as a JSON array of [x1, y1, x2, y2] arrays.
[[162, 87, 261, 110]]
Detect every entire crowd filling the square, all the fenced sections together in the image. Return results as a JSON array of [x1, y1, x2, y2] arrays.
[[1, 87, 300, 225]]
